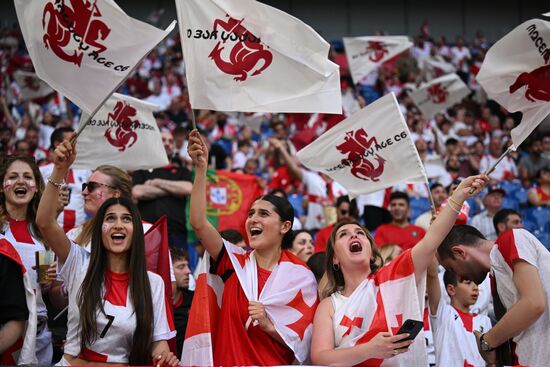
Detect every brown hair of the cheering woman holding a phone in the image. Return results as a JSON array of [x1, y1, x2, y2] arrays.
[[321, 218, 384, 298]]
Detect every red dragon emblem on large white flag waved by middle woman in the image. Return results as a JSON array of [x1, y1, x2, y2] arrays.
[[208, 17, 273, 81]]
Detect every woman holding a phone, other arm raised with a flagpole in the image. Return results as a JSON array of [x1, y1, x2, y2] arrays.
[[311, 175, 488, 367]]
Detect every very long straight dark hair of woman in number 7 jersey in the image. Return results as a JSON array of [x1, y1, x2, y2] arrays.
[[77, 197, 153, 366]]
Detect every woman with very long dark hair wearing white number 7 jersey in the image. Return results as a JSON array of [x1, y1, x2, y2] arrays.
[[36, 141, 179, 366]]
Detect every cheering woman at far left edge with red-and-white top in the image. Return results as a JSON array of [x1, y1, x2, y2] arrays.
[[0, 156, 52, 365]]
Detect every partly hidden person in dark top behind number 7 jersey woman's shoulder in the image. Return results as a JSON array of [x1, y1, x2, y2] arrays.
[[174, 247, 195, 356]]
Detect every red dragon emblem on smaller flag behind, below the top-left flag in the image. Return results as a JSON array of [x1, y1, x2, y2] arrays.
[[105, 101, 139, 152]]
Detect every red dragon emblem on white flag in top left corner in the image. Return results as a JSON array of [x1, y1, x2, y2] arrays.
[[42, 0, 111, 66]]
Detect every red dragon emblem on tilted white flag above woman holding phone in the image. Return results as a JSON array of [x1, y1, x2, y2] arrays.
[[336, 129, 386, 182]]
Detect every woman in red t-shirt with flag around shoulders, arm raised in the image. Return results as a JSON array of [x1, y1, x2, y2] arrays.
[[190, 130, 317, 366]]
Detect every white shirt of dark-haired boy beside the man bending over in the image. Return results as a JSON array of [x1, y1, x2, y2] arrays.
[[430, 297, 491, 367]]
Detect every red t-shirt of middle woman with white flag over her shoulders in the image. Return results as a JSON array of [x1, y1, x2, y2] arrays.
[[211, 249, 294, 366]]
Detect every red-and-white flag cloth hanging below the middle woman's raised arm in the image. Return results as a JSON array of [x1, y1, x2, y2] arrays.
[[180, 252, 223, 367]]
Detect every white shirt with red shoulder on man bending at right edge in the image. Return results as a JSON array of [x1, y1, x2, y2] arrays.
[[490, 229, 550, 366]]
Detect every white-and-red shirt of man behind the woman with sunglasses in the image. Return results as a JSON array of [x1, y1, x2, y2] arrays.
[[40, 163, 92, 232]]
